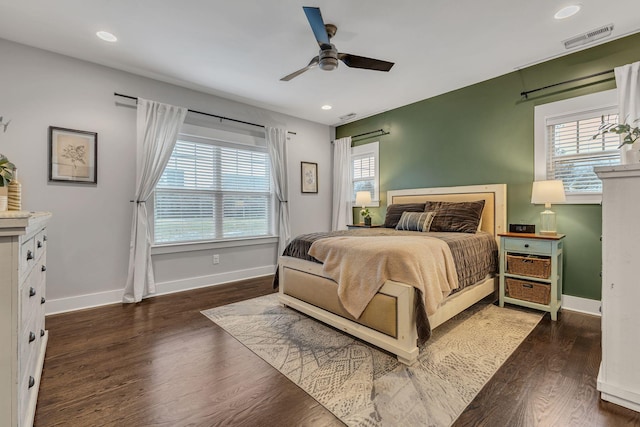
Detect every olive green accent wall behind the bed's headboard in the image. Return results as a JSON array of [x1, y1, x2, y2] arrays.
[[336, 34, 640, 300]]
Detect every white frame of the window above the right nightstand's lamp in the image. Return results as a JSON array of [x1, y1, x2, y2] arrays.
[[534, 89, 618, 204]]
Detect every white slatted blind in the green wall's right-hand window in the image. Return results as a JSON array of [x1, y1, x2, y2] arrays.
[[547, 112, 620, 195]]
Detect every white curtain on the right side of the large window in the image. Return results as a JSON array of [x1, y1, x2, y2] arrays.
[[264, 126, 291, 255]]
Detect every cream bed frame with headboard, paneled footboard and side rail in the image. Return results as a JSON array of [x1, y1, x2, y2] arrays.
[[276, 184, 506, 365]]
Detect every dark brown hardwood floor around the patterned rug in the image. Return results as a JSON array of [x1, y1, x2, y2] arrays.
[[35, 277, 640, 427]]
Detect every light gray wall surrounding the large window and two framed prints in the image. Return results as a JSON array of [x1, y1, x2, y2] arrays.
[[0, 39, 332, 312]]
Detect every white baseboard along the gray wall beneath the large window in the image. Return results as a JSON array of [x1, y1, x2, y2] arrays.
[[46, 265, 276, 315]]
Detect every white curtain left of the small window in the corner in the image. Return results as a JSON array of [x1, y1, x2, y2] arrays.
[[331, 136, 353, 230]]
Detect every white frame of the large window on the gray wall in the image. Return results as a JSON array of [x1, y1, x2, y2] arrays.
[[153, 124, 278, 249]]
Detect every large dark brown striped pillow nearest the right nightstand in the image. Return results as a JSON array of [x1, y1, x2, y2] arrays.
[[424, 200, 484, 233]]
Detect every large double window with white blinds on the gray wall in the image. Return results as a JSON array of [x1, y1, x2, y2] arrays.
[[154, 140, 273, 244]]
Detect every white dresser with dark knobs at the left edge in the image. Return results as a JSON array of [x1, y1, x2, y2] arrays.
[[0, 211, 51, 427]]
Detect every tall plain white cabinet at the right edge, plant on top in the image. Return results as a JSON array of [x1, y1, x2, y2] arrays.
[[595, 165, 640, 411]]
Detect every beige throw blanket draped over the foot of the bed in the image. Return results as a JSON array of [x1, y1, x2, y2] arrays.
[[309, 236, 458, 319]]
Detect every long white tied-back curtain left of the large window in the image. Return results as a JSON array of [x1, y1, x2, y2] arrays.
[[122, 98, 187, 303]]
